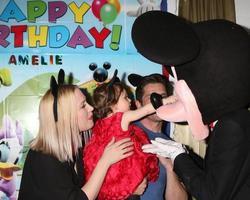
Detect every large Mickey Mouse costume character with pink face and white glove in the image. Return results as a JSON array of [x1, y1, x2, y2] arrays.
[[132, 11, 250, 200]]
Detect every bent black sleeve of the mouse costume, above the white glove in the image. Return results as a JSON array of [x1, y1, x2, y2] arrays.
[[174, 117, 249, 200]]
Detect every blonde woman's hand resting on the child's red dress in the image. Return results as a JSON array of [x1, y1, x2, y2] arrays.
[[101, 137, 134, 166]]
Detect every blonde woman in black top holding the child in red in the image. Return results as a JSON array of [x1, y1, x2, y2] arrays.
[[18, 71, 146, 200]]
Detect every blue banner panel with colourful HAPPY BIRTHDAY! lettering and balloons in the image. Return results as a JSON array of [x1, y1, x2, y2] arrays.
[[0, 0, 124, 53]]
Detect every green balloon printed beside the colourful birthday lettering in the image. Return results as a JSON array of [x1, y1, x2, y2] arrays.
[[100, 3, 117, 25]]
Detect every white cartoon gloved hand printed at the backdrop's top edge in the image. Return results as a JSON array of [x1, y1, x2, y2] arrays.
[[127, 0, 160, 17]]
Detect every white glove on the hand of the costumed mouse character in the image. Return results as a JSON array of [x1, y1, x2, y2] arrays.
[[142, 138, 187, 163]]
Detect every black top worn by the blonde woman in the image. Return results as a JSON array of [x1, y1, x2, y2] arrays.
[[18, 150, 88, 200]]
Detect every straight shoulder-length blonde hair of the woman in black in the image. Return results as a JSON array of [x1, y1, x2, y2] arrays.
[[31, 85, 82, 162]]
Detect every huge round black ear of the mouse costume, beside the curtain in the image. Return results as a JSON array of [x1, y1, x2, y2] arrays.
[[131, 10, 200, 66]]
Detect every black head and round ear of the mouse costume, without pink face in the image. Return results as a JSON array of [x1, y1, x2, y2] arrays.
[[132, 11, 250, 124]]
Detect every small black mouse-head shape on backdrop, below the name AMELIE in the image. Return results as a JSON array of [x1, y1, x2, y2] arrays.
[[89, 62, 111, 82]]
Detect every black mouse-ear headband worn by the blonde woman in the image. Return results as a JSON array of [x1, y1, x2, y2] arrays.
[[50, 69, 73, 122]]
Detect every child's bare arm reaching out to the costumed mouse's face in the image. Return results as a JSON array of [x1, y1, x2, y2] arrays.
[[121, 96, 176, 131]]
